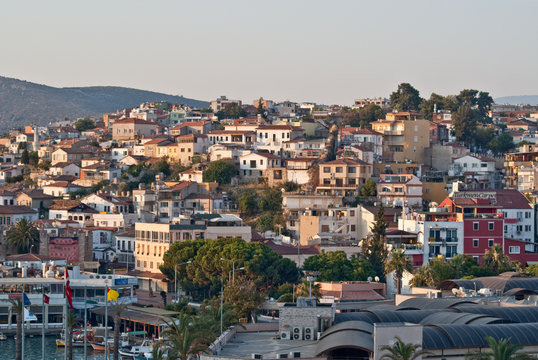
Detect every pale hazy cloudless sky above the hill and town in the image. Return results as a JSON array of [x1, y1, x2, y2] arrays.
[[0, 0, 538, 105]]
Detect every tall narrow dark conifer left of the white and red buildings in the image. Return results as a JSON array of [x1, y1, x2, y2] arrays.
[[362, 203, 388, 279]]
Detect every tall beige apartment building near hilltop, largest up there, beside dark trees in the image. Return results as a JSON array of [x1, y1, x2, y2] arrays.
[[372, 112, 430, 163]]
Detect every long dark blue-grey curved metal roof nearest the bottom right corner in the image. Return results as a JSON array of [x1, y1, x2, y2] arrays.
[[422, 324, 538, 350]]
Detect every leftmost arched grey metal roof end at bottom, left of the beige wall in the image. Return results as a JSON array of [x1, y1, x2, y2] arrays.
[[316, 321, 374, 356]]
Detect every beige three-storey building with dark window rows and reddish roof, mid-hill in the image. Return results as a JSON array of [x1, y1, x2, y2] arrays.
[[317, 158, 373, 196]]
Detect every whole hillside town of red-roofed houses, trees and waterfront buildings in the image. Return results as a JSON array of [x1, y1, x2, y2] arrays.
[[0, 83, 538, 360]]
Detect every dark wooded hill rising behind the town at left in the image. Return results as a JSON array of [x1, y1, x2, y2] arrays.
[[0, 76, 209, 130]]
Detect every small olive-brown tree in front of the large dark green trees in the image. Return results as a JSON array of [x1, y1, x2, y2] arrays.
[[223, 276, 265, 318]]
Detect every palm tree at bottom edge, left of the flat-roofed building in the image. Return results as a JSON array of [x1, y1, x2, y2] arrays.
[[161, 314, 214, 360]]
